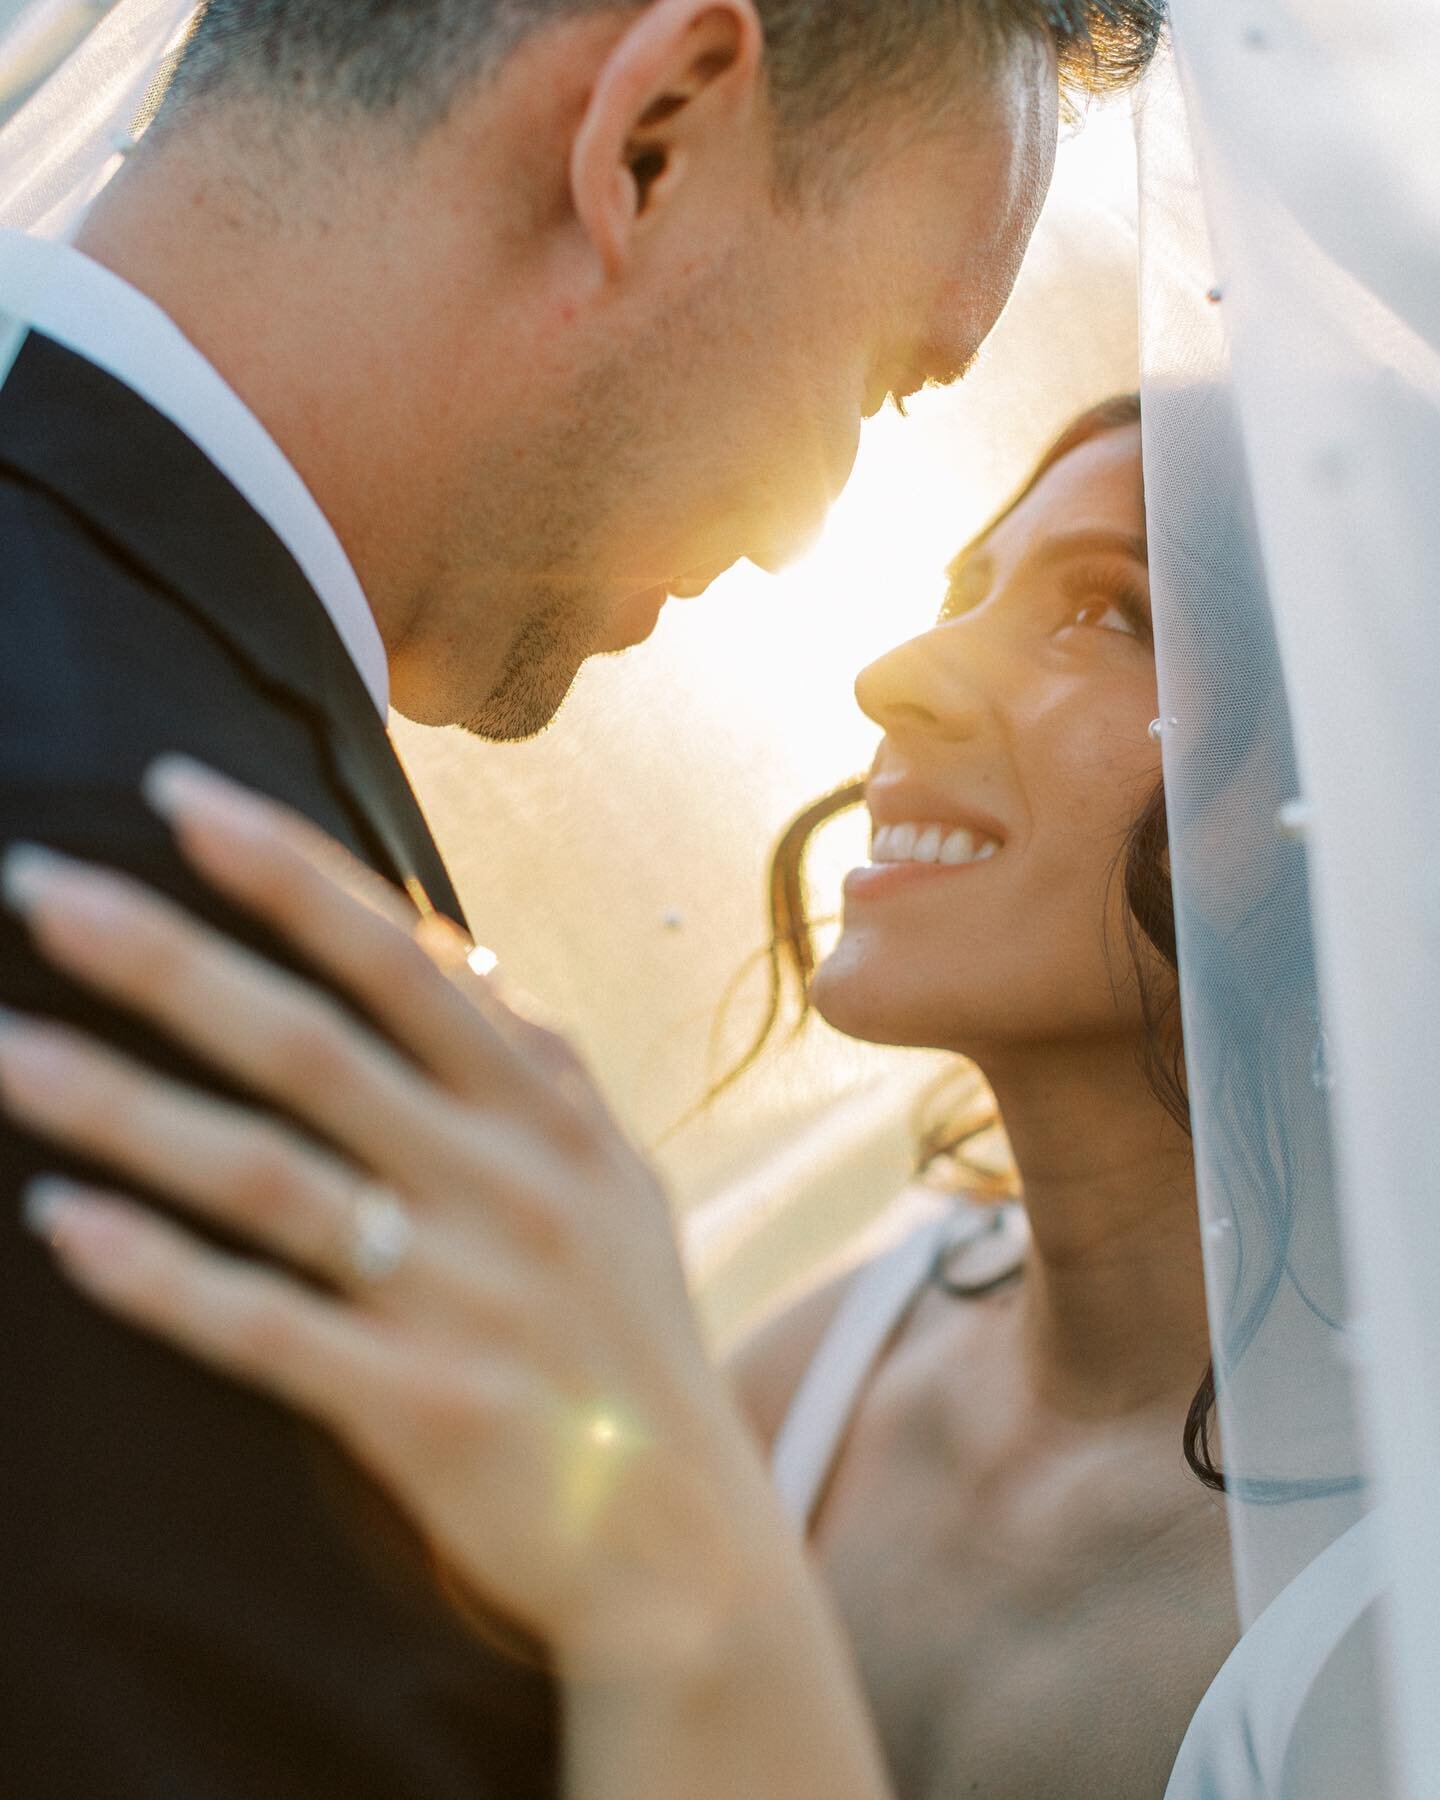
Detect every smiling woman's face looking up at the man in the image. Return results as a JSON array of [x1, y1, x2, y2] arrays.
[[814, 427, 1161, 1057]]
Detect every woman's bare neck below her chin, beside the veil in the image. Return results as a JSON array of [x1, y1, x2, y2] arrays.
[[986, 1040, 1210, 1417]]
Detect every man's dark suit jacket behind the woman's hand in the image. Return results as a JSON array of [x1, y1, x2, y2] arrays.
[[0, 337, 556, 1800]]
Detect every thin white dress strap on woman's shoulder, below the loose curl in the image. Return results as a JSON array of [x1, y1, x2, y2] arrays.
[[770, 1206, 992, 1532]]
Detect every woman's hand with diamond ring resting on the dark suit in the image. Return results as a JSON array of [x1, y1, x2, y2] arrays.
[[0, 760, 783, 1674]]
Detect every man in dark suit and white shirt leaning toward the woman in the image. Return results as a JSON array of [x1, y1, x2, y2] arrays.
[[0, 0, 1159, 1800]]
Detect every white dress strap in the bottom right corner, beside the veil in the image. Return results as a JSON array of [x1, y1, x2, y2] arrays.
[[1165, 1512, 1382, 1800]]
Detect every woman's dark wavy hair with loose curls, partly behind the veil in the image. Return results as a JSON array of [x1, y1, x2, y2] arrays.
[[718, 394, 1352, 1501]]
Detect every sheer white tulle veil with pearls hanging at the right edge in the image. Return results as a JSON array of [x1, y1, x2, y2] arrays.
[[1139, 0, 1440, 1796]]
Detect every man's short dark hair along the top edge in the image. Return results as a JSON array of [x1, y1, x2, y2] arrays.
[[162, 0, 1165, 141]]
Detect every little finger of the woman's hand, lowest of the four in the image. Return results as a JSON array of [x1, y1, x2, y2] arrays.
[[25, 1179, 396, 1433]]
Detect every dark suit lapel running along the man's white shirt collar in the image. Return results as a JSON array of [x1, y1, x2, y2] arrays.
[[0, 333, 464, 923]]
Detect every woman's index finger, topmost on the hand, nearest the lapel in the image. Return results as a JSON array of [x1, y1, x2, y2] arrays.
[[146, 756, 550, 1096]]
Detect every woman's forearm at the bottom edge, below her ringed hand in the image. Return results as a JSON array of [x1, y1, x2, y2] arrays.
[[563, 1561, 893, 1800]]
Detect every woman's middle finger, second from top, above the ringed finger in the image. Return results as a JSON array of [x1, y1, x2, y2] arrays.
[[4, 846, 448, 1183]]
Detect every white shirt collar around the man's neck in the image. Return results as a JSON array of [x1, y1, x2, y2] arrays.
[[0, 230, 391, 718]]
